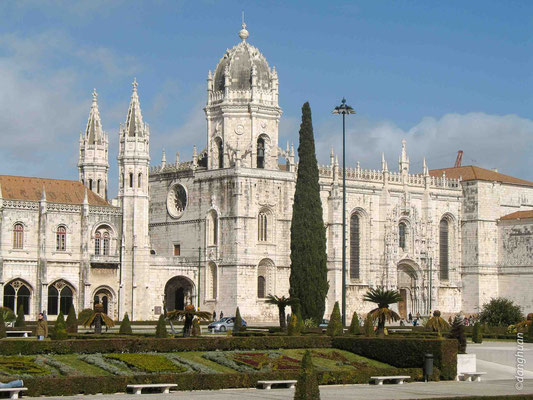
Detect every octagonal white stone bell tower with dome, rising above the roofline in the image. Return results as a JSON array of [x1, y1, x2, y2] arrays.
[[204, 21, 282, 169]]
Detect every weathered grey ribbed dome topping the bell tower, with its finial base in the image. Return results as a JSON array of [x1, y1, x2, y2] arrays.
[[213, 23, 271, 92]]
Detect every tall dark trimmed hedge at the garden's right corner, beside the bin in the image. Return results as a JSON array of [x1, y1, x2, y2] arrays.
[[332, 337, 458, 380]]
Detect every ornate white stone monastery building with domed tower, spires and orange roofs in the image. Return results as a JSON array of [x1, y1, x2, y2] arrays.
[[0, 24, 533, 322]]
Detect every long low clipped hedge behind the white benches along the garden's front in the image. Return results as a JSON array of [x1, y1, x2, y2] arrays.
[[24, 368, 423, 397]]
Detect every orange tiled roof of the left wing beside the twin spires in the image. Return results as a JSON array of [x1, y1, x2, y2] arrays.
[[0, 175, 111, 206]]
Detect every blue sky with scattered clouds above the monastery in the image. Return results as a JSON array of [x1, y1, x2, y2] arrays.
[[0, 0, 533, 197]]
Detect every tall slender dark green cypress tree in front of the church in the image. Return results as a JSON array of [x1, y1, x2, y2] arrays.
[[289, 102, 329, 325]]
